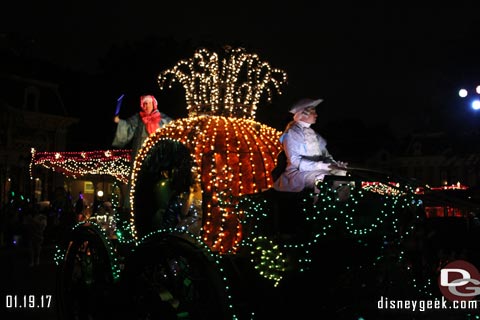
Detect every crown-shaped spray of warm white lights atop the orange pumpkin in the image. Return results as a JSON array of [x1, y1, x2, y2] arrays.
[[158, 47, 287, 119]]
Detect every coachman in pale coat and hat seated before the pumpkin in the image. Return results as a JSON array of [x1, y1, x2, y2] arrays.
[[273, 99, 347, 199]]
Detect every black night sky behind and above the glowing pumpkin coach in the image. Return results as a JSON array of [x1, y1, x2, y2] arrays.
[[0, 0, 480, 155]]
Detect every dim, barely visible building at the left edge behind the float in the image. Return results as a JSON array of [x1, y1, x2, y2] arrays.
[[0, 74, 78, 204]]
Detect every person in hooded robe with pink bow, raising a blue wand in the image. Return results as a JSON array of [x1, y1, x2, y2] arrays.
[[112, 95, 172, 209]]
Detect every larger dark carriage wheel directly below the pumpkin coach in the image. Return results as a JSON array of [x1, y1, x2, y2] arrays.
[[122, 235, 232, 319]]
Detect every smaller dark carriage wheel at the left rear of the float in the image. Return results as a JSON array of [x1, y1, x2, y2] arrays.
[[57, 227, 113, 319]]
